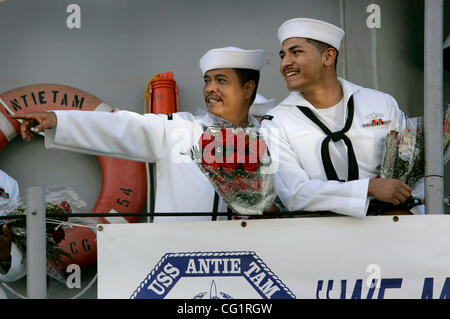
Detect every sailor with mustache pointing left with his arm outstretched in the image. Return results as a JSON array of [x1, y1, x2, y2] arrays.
[[5, 47, 264, 282]]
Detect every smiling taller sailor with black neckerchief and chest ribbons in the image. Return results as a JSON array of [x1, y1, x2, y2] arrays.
[[261, 18, 422, 217]]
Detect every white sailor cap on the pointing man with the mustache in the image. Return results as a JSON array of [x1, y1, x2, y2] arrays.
[[199, 47, 265, 75]]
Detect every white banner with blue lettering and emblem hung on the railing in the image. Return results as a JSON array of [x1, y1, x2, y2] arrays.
[[97, 215, 450, 299]]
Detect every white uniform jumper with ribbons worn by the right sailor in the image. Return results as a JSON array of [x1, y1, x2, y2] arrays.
[[261, 79, 401, 218]]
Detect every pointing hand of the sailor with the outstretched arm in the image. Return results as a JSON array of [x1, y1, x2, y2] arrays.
[[11, 112, 57, 142]]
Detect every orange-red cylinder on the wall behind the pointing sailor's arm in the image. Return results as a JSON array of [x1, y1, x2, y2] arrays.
[[144, 72, 179, 114]]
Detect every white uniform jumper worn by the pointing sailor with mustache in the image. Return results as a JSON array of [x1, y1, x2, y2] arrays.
[[45, 111, 258, 222]]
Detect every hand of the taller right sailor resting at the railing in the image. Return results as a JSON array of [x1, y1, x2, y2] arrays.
[[368, 178, 411, 205]]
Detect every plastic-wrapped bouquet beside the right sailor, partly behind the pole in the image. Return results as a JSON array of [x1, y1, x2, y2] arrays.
[[380, 107, 450, 188]]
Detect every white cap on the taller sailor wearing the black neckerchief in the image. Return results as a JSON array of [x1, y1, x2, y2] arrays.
[[278, 18, 345, 51]]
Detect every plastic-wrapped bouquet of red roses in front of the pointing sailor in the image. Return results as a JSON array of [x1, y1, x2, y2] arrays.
[[191, 124, 276, 215]]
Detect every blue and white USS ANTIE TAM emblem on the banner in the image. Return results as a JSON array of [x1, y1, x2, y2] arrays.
[[130, 251, 295, 299]]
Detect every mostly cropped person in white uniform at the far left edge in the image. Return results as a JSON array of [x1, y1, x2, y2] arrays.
[[0, 170, 26, 282]]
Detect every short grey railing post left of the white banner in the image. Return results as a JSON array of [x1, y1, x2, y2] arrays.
[[26, 187, 47, 299]]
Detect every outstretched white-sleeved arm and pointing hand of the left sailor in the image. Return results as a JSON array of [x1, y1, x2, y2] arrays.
[[15, 110, 174, 162]]
